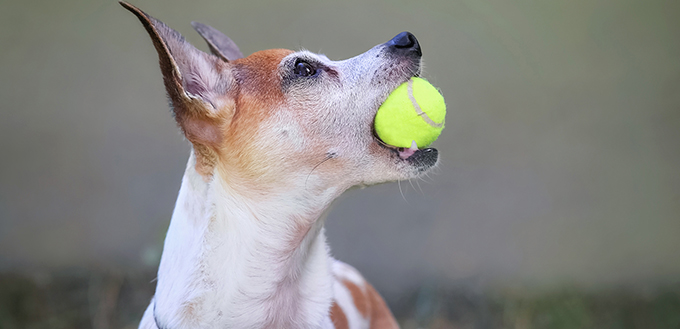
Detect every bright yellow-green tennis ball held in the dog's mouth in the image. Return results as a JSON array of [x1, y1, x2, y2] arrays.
[[375, 77, 446, 149]]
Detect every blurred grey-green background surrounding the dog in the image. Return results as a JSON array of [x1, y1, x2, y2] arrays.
[[0, 0, 680, 329]]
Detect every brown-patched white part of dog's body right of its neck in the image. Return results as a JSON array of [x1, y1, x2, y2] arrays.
[[331, 260, 399, 329]]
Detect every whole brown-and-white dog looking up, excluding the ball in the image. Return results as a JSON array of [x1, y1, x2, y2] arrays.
[[120, 1, 439, 329]]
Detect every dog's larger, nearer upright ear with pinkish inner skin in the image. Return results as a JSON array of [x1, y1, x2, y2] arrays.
[[120, 1, 235, 173]]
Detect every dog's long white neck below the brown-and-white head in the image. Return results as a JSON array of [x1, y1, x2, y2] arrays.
[[154, 156, 337, 328]]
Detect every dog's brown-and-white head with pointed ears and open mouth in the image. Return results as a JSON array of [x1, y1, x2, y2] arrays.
[[121, 2, 438, 197]]
